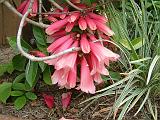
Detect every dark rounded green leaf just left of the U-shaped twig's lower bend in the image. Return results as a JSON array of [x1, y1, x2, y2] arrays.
[[12, 54, 27, 71]]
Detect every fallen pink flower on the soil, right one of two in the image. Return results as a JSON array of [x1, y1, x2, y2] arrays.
[[62, 92, 72, 110]]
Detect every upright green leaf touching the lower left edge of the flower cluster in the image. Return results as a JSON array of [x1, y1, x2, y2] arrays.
[[43, 66, 52, 85]]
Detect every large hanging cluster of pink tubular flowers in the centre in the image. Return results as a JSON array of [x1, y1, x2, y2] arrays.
[[18, 0, 119, 94]]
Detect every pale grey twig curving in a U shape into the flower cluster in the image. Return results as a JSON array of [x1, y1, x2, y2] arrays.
[[17, 0, 80, 61]]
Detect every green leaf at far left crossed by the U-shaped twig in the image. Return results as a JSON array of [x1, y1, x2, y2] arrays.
[[7, 36, 32, 53]]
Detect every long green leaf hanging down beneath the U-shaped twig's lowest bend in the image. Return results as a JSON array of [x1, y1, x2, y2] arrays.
[[25, 61, 38, 87]]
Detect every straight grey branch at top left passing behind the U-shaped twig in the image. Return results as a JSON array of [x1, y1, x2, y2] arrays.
[[3, 0, 49, 28]]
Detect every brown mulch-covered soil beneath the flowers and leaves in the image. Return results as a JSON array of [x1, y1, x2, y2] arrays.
[[0, 47, 158, 120]]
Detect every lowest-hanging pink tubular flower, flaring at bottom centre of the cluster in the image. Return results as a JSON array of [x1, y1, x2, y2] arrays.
[[80, 57, 95, 94]]
